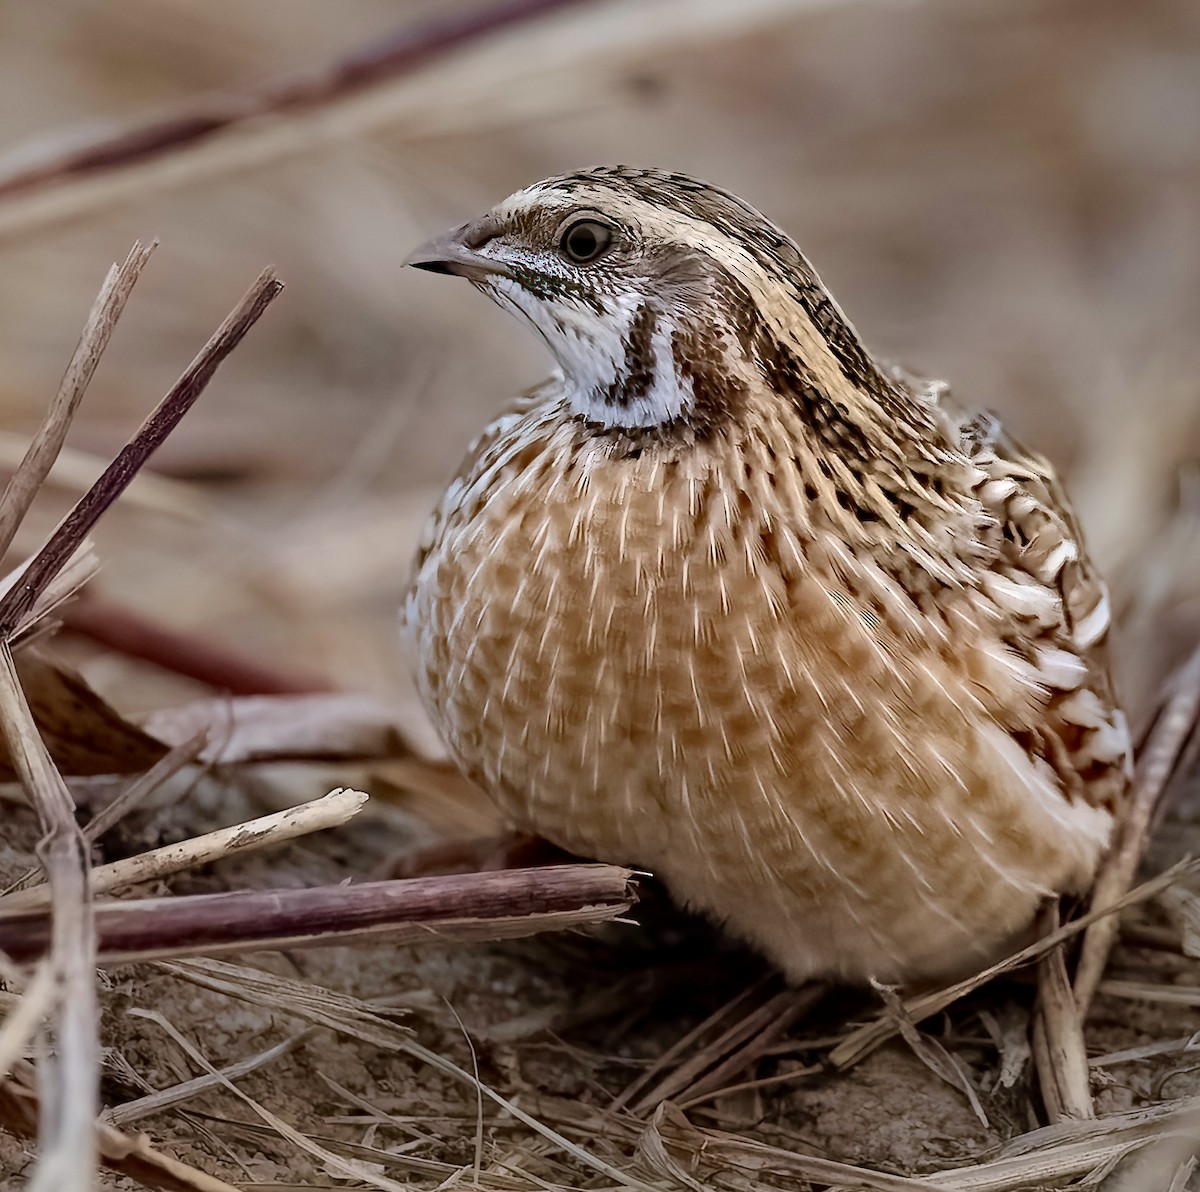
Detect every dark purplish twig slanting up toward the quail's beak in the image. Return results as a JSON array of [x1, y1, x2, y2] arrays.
[[0, 269, 283, 640]]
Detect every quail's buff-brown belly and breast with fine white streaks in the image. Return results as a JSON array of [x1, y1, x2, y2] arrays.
[[409, 480, 1109, 980]]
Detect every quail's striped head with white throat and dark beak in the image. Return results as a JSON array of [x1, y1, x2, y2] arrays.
[[408, 166, 907, 439]]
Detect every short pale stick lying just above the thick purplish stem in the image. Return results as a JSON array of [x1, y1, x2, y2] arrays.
[[0, 787, 368, 915]]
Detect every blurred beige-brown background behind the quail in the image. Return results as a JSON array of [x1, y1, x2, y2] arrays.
[[0, 0, 1200, 713]]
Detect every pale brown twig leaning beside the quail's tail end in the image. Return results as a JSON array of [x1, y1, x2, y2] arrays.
[[1074, 649, 1200, 1018]]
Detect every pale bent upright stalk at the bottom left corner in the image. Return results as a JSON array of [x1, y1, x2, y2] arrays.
[[0, 643, 100, 1192]]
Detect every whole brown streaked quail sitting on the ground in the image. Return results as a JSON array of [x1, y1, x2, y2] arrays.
[[403, 167, 1129, 981]]
